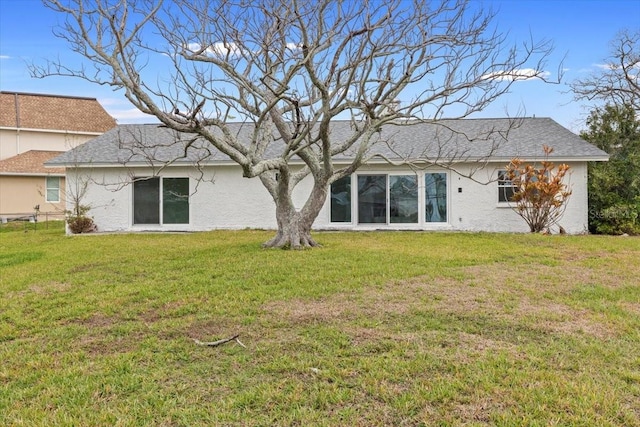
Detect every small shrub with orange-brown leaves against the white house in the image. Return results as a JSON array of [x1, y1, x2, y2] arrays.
[[505, 145, 571, 233]]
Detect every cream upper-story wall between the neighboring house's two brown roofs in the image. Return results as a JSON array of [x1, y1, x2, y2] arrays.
[[0, 128, 99, 160]]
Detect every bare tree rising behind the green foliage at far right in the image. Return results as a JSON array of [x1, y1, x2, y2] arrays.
[[571, 29, 640, 114]]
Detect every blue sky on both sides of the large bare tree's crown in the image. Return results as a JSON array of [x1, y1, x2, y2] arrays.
[[0, 0, 640, 133]]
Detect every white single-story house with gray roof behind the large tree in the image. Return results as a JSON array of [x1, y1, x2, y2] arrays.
[[47, 118, 608, 233]]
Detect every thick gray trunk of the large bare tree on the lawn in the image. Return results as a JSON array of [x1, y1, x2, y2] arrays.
[[262, 179, 327, 249]]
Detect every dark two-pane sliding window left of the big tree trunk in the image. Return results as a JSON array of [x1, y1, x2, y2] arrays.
[[133, 177, 189, 224]]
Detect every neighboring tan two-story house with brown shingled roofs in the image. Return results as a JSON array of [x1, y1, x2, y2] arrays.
[[0, 91, 116, 221]]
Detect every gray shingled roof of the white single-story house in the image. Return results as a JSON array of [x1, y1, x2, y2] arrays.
[[47, 118, 608, 167]]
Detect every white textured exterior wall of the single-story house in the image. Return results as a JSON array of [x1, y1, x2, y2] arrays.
[[67, 162, 587, 233]]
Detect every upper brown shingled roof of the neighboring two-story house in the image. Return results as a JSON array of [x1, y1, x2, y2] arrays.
[[0, 91, 116, 133]]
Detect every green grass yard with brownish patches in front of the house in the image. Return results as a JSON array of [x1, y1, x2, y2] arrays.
[[0, 225, 640, 426]]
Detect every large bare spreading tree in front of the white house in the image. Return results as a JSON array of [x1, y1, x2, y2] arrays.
[[32, 0, 551, 248]]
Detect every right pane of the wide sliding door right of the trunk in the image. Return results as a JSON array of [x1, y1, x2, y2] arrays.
[[389, 175, 418, 224]]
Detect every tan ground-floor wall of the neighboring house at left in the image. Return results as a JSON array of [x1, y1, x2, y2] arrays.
[[0, 175, 66, 216]]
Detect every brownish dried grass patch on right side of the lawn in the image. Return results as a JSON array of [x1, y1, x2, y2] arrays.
[[263, 263, 620, 340]]
